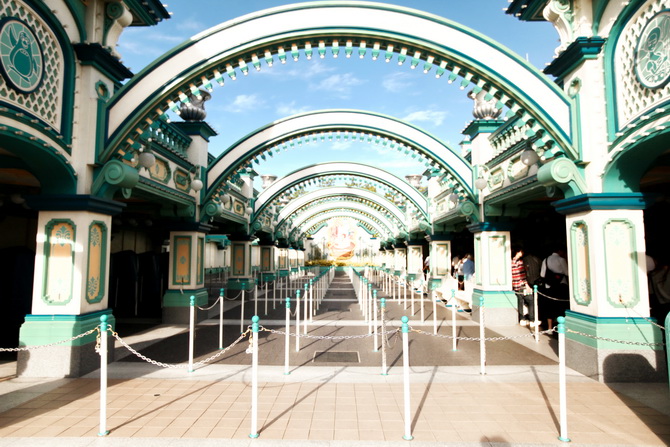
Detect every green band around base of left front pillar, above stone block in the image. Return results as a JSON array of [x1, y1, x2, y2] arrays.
[[19, 309, 116, 346]]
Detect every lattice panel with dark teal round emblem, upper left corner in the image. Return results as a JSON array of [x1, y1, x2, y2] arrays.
[[0, 0, 64, 131]]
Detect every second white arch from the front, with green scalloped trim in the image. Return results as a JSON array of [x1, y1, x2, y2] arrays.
[[207, 110, 472, 205]]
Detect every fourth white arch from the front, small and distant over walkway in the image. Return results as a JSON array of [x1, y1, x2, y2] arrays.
[[270, 188, 407, 233]]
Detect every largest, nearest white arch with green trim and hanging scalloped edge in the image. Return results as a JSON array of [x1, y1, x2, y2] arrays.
[[107, 2, 574, 166]]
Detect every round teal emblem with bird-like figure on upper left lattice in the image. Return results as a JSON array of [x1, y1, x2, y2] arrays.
[[0, 17, 44, 93]]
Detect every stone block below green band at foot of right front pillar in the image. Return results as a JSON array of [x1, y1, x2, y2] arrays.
[[565, 339, 668, 383]]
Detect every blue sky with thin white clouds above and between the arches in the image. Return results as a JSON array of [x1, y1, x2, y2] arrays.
[[117, 0, 559, 187]]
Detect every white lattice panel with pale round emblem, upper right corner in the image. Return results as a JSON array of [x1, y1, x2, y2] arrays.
[[614, 0, 670, 128]]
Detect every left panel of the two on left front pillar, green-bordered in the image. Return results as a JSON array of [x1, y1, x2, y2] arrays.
[[42, 219, 76, 305]]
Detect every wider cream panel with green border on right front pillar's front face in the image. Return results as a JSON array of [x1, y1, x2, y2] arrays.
[[603, 219, 640, 308]]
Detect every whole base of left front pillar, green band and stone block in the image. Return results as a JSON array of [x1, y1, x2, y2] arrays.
[[16, 309, 115, 377]]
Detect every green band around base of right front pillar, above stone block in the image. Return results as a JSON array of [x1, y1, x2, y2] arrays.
[[565, 310, 663, 351]]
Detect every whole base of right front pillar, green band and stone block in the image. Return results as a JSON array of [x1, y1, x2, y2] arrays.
[[565, 311, 667, 383]]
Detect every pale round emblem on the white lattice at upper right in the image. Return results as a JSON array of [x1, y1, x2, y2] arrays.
[[635, 10, 670, 89]]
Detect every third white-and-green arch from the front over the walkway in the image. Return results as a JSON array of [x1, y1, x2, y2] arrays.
[[254, 162, 427, 216]]
